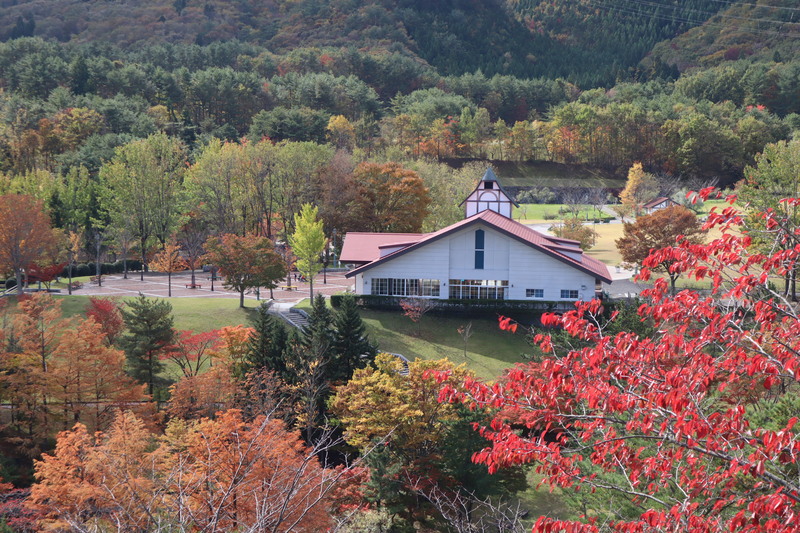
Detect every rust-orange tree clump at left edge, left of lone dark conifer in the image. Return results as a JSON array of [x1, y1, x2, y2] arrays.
[[0, 293, 147, 446]]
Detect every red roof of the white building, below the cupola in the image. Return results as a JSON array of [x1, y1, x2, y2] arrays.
[[342, 209, 611, 283]]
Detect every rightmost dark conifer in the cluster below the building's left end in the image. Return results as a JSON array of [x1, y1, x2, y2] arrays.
[[330, 294, 377, 383]]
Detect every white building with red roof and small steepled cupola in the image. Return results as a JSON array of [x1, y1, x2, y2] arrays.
[[341, 169, 611, 301]]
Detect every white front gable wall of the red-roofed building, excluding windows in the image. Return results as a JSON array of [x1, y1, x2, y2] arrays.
[[355, 225, 595, 301]]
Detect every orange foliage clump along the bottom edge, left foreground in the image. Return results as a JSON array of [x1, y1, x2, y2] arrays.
[[31, 410, 351, 532]]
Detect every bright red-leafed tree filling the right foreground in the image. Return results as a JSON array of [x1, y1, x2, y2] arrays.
[[442, 190, 800, 533]]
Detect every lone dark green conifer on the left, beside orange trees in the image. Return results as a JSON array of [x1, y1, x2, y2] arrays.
[[120, 295, 175, 396]]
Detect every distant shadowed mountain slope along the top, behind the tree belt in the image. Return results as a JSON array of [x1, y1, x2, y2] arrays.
[[0, 0, 736, 87]]
